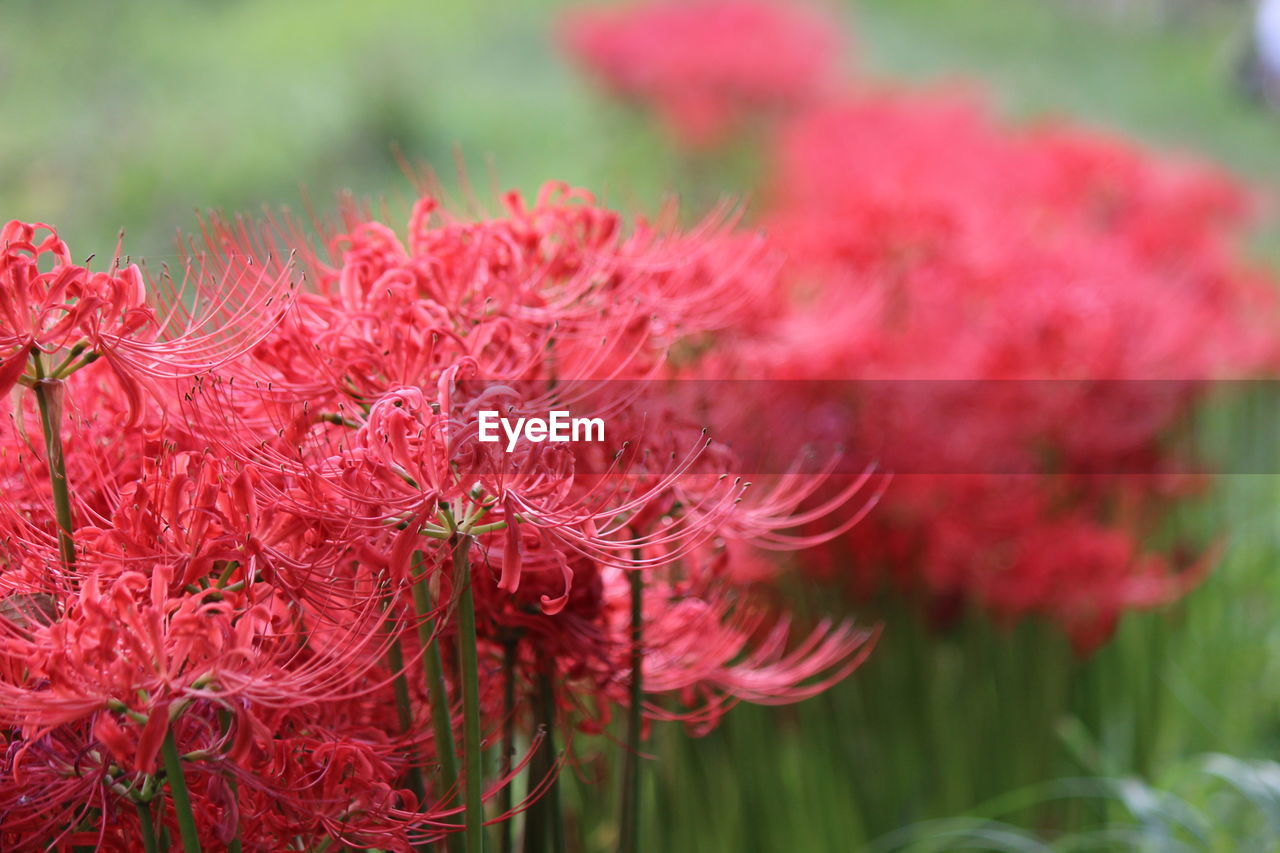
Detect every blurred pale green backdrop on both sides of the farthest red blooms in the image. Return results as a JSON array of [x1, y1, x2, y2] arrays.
[[10, 0, 1280, 256]]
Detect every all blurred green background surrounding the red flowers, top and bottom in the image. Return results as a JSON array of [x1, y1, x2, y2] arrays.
[[0, 0, 1280, 852]]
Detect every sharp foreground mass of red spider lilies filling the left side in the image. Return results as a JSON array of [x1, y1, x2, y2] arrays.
[[0, 186, 872, 852]]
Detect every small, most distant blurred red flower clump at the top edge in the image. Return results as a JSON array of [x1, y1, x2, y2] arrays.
[[564, 0, 840, 147]]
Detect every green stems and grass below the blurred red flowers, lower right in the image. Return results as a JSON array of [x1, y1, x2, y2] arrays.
[[565, 397, 1280, 853]]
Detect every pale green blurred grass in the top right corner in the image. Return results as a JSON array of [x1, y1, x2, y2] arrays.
[[855, 0, 1280, 181]]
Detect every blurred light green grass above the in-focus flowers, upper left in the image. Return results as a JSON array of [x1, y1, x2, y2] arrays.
[[0, 0, 659, 257]]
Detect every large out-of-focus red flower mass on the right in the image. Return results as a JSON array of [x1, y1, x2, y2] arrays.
[[764, 93, 1277, 649]]
